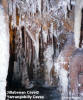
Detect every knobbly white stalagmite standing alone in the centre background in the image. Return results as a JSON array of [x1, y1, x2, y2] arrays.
[[44, 45, 54, 86]]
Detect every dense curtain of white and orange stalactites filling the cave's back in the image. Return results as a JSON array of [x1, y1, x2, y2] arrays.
[[9, 0, 73, 88]]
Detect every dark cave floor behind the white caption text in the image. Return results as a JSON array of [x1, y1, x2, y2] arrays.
[[6, 80, 61, 100]]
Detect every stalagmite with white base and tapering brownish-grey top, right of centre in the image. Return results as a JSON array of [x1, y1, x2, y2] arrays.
[[54, 33, 75, 96]]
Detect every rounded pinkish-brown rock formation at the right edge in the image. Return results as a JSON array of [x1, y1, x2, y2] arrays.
[[70, 49, 83, 96]]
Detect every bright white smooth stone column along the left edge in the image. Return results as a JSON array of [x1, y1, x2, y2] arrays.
[[0, 1, 9, 100]]
